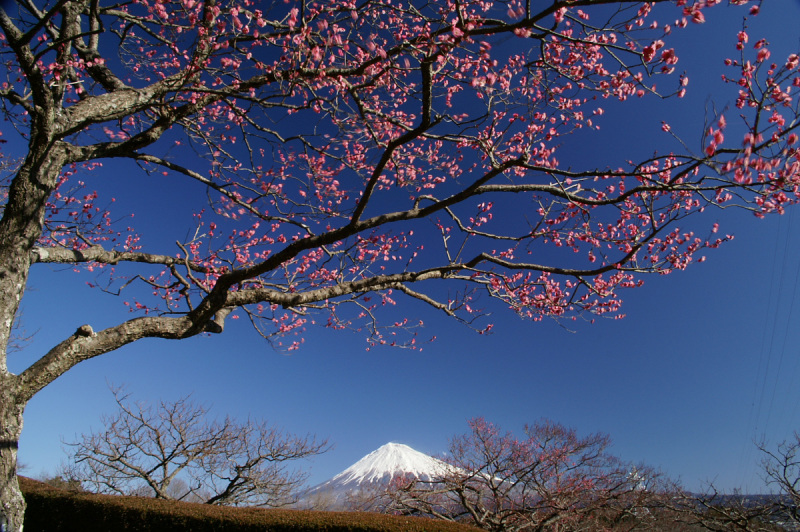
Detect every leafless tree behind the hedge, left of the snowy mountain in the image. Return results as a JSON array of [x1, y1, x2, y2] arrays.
[[68, 389, 328, 507]]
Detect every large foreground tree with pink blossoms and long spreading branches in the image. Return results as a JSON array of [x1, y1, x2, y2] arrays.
[[0, 0, 800, 530]]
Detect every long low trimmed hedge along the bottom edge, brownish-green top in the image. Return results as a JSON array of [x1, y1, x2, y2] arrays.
[[19, 477, 476, 532]]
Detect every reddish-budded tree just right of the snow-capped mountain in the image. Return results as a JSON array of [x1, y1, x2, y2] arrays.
[[392, 419, 660, 531]]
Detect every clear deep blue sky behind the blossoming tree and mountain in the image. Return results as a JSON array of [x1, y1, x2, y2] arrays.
[[4, 0, 800, 491]]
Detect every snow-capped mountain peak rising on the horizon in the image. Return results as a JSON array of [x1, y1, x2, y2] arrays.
[[301, 443, 450, 509]]
